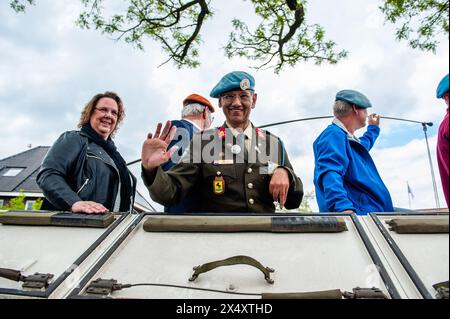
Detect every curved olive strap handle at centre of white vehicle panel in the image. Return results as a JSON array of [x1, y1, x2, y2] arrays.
[[189, 256, 275, 284]]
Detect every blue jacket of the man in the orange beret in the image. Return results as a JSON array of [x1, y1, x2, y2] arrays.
[[162, 120, 201, 214]]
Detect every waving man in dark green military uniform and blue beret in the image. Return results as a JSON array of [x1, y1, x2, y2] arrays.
[[141, 72, 303, 213]]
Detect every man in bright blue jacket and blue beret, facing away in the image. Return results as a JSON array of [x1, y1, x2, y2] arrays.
[[314, 90, 394, 215]]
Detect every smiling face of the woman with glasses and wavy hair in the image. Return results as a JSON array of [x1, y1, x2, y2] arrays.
[[89, 97, 119, 140]]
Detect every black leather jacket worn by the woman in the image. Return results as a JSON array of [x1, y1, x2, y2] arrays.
[[36, 131, 136, 211]]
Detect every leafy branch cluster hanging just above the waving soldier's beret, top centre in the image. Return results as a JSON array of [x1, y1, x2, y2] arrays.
[[225, 0, 348, 73]]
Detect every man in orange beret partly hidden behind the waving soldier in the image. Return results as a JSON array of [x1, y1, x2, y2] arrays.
[[161, 94, 215, 213]]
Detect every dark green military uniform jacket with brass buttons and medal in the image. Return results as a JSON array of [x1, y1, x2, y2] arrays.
[[142, 125, 303, 213]]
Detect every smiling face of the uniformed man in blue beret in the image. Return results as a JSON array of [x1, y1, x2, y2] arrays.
[[219, 90, 257, 129]]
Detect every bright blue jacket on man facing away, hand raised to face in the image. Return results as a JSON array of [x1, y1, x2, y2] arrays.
[[314, 123, 394, 215]]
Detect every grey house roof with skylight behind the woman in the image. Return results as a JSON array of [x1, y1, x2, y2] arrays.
[[0, 146, 50, 193]]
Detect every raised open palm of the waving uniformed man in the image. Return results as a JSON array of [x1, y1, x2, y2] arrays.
[[141, 121, 178, 171]]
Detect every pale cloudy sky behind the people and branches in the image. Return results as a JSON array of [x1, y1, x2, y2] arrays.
[[0, 0, 449, 209]]
